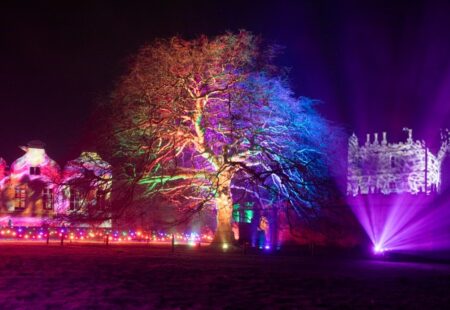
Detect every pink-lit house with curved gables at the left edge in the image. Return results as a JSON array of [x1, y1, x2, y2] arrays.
[[0, 141, 111, 226]]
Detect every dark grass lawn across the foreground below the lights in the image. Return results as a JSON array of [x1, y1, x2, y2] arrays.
[[0, 243, 450, 309]]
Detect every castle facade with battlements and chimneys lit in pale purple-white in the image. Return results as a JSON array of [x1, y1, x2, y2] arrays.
[[347, 128, 450, 196]]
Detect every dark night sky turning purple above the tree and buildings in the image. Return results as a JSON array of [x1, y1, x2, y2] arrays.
[[0, 0, 450, 164]]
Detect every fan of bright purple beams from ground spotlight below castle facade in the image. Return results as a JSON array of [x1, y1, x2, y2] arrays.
[[350, 194, 450, 254]]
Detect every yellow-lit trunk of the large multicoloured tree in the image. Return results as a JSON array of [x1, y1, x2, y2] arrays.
[[212, 176, 235, 247]]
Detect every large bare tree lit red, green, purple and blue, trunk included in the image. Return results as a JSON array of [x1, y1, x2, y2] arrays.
[[106, 31, 338, 242]]
